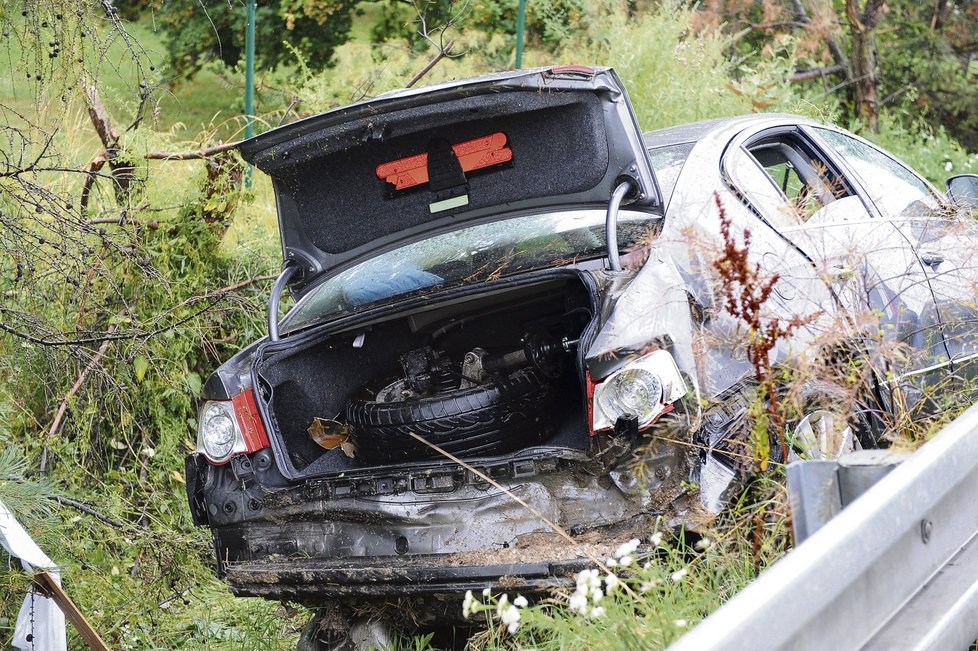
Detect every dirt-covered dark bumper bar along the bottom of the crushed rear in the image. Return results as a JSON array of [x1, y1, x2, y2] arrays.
[[226, 554, 592, 605]]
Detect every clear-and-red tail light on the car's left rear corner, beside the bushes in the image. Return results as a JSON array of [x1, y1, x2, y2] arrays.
[[197, 389, 268, 464]]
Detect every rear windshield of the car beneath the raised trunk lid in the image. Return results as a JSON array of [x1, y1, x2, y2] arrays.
[[283, 210, 661, 330]]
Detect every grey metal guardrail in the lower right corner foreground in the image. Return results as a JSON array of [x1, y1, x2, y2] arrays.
[[669, 405, 978, 651]]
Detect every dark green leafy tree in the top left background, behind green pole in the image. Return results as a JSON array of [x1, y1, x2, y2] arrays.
[[154, 0, 357, 77]]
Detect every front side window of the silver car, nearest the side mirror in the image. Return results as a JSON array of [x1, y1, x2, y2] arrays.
[[815, 127, 940, 217]]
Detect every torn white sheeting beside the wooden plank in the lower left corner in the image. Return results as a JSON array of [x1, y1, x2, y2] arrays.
[[0, 501, 68, 651]]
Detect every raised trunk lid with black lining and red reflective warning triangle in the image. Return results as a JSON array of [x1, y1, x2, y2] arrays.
[[240, 66, 661, 295]]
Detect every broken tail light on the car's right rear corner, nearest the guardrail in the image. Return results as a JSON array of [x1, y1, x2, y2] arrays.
[[587, 350, 688, 432]]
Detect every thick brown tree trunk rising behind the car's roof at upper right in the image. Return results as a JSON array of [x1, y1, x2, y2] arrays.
[[846, 0, 887, 131]]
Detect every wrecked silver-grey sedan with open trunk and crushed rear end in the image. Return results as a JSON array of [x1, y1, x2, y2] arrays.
[[186, 66, 978, 648]]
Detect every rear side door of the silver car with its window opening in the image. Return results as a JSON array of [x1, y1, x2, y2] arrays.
[[735, 125, 948, 403]]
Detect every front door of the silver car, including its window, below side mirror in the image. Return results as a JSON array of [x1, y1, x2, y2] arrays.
[[813, 128, 978, 392]]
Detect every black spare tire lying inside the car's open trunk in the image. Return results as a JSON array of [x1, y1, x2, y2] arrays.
[[346, 369, 558, 463]]
